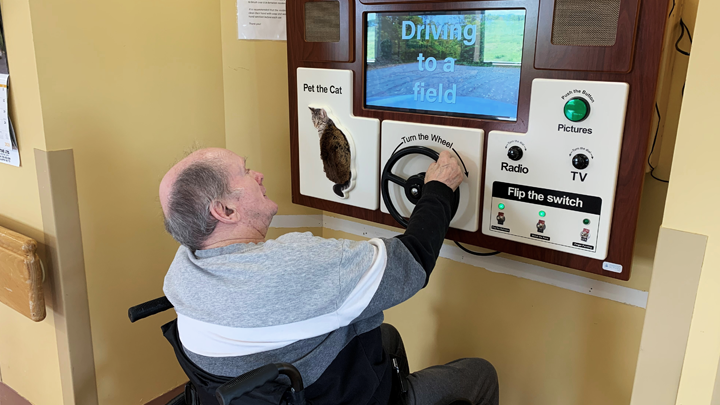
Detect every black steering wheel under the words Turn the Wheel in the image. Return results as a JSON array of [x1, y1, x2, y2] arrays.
[[380, 146, 460, 228]]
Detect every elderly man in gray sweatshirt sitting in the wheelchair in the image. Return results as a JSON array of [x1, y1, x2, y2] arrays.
[[160, 149, 499, 405]]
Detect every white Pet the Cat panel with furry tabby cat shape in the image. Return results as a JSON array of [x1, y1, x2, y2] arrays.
[[297, 68, 380, 210]]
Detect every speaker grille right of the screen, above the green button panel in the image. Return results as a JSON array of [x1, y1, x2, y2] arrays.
[[552, 0, 620, 46]]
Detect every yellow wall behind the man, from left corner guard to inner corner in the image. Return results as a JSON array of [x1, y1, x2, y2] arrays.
[[20, 0, 225, 405]]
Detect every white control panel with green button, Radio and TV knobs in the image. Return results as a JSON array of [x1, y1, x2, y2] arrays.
[[482, 79, 629, 260]]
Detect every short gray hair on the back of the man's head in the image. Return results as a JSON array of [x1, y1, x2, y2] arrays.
[[165, 161, 230, 251]]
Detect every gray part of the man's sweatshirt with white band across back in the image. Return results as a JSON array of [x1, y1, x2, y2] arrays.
[[164, 232, 427, 386]]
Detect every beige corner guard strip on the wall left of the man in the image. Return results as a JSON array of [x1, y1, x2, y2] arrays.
[[35, 149, 98, 405]]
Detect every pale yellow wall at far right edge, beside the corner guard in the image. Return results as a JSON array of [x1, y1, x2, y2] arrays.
[[663, 0, 720, 405]]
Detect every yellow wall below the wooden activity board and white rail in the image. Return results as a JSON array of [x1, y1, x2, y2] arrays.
[[323, 229, 645, 405]]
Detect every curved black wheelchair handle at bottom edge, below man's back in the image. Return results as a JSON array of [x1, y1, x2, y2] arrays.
[[215, 363, 304, 405]]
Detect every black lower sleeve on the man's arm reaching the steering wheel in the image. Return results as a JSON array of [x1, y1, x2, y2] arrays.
[[397, 181, 453, 285]]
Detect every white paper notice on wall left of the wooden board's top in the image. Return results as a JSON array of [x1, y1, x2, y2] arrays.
[[238, 0, 287, 41]]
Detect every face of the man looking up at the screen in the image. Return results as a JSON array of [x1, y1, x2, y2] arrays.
[[228, 154, 278, 225]]
